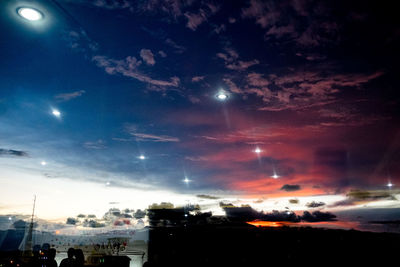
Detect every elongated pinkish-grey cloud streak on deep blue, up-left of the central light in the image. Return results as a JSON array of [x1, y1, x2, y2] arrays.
[[92, 55, 180, 87]]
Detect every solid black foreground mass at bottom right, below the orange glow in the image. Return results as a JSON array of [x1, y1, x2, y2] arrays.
[[149, 223, 400, 267]]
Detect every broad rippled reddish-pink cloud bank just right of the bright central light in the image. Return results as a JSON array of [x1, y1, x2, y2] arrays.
[[227, 69, 384, 112]]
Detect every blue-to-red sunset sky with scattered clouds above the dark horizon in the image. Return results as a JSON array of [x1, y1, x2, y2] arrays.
[[0, 0, 400, 231]]
